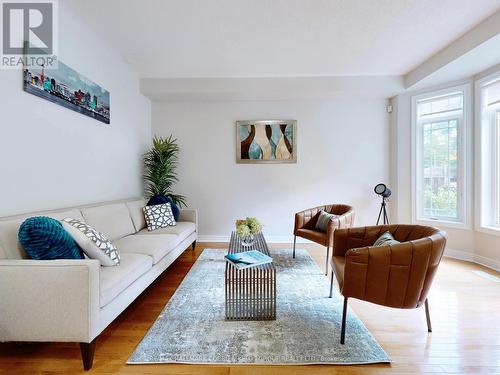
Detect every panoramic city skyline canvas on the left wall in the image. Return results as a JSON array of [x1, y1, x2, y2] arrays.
[[23, 61, 110, 124]]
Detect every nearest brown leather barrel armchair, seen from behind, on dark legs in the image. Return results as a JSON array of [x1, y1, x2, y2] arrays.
[[330, 225, 446, 344]]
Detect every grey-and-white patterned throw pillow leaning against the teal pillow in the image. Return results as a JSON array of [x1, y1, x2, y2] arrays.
[[61, 218, 120, 267]]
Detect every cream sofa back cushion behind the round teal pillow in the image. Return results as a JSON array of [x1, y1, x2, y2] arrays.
[[0, 209, 83, 259]]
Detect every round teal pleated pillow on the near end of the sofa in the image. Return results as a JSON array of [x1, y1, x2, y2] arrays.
[[18, 216, 83, 260]]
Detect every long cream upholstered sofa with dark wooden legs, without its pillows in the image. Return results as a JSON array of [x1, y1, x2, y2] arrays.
[[0, 198, 198, 370]]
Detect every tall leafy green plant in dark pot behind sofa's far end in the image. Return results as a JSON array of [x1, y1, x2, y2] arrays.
[[144, 135, 186, 220]]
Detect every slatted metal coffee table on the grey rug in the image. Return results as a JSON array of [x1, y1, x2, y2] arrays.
[[225, 232, 276, 320]]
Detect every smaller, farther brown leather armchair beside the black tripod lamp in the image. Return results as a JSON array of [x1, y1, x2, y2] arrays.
[[293, 204, 354, 275]]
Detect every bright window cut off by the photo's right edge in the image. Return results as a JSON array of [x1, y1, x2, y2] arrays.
[[477, 76, 500, 230]]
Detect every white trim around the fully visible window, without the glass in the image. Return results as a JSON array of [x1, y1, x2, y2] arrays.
[[411, 83, 473, 229]]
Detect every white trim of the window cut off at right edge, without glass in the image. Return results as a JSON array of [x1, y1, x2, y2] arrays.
[[474, 72, 500, 236]]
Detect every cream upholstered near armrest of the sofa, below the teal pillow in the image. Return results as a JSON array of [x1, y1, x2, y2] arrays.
[[0, 259, 100, 342]]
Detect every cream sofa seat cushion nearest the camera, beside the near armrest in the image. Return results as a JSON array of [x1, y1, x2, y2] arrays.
[[99, 253, 153, 307]]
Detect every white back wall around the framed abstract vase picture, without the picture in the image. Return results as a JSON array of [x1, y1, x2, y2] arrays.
[[152, 99, 389, 241]]
